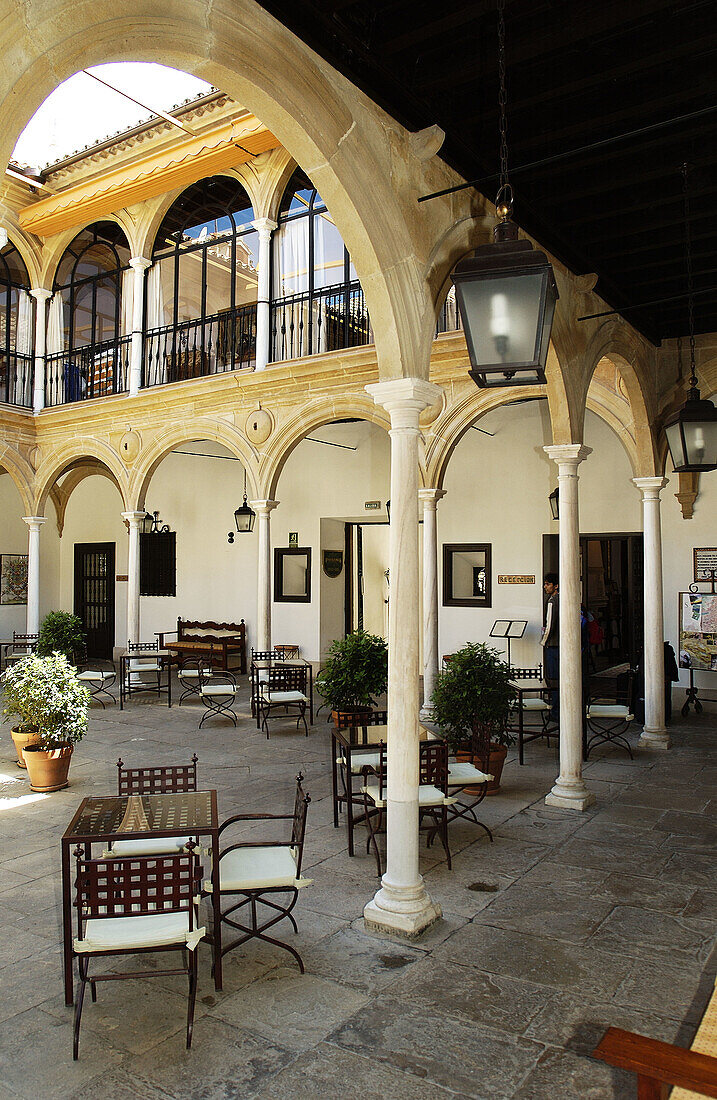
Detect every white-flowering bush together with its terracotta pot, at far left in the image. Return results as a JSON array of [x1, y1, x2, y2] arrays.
[[2, 653, 89, 791]]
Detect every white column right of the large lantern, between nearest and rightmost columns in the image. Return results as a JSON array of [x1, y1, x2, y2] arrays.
[[543, 443, 595, 810]]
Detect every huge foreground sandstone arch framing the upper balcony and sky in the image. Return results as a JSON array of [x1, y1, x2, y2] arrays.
[[0, 8, 432, 377]]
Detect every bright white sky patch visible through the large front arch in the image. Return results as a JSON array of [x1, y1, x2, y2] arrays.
[[12, 62, 212, 172]]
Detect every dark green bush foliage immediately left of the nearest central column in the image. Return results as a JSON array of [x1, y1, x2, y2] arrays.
[[317, 630, 388, 711]]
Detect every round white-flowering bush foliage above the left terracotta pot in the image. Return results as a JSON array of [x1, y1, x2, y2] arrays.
[[2, 653, 89, 750]]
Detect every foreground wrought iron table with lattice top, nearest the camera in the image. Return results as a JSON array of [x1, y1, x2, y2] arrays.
[[62, 791, 222, 1004]]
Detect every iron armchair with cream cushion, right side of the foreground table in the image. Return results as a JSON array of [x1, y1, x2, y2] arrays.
[[202, 773, 311, 974]]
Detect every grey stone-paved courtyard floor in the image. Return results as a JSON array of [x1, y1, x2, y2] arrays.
[[0, 677, 717, 1100]]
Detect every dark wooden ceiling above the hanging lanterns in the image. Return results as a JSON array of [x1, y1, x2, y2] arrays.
[[256, 0, 717, 342]]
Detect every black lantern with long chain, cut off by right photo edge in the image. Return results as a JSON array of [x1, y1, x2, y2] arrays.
[[664, 164, 717, 474]]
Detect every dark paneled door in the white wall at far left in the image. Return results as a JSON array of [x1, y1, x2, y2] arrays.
[[75, 542, 114, 660]]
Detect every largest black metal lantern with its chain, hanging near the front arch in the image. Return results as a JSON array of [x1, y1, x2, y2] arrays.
[[451, 0, 558, 388]]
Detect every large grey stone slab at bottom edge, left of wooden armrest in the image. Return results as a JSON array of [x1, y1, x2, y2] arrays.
[[330, 996, 543, 1100]]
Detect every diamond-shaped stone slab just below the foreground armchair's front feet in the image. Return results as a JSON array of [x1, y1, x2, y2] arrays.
[[211, 967, 368, 1052]]
